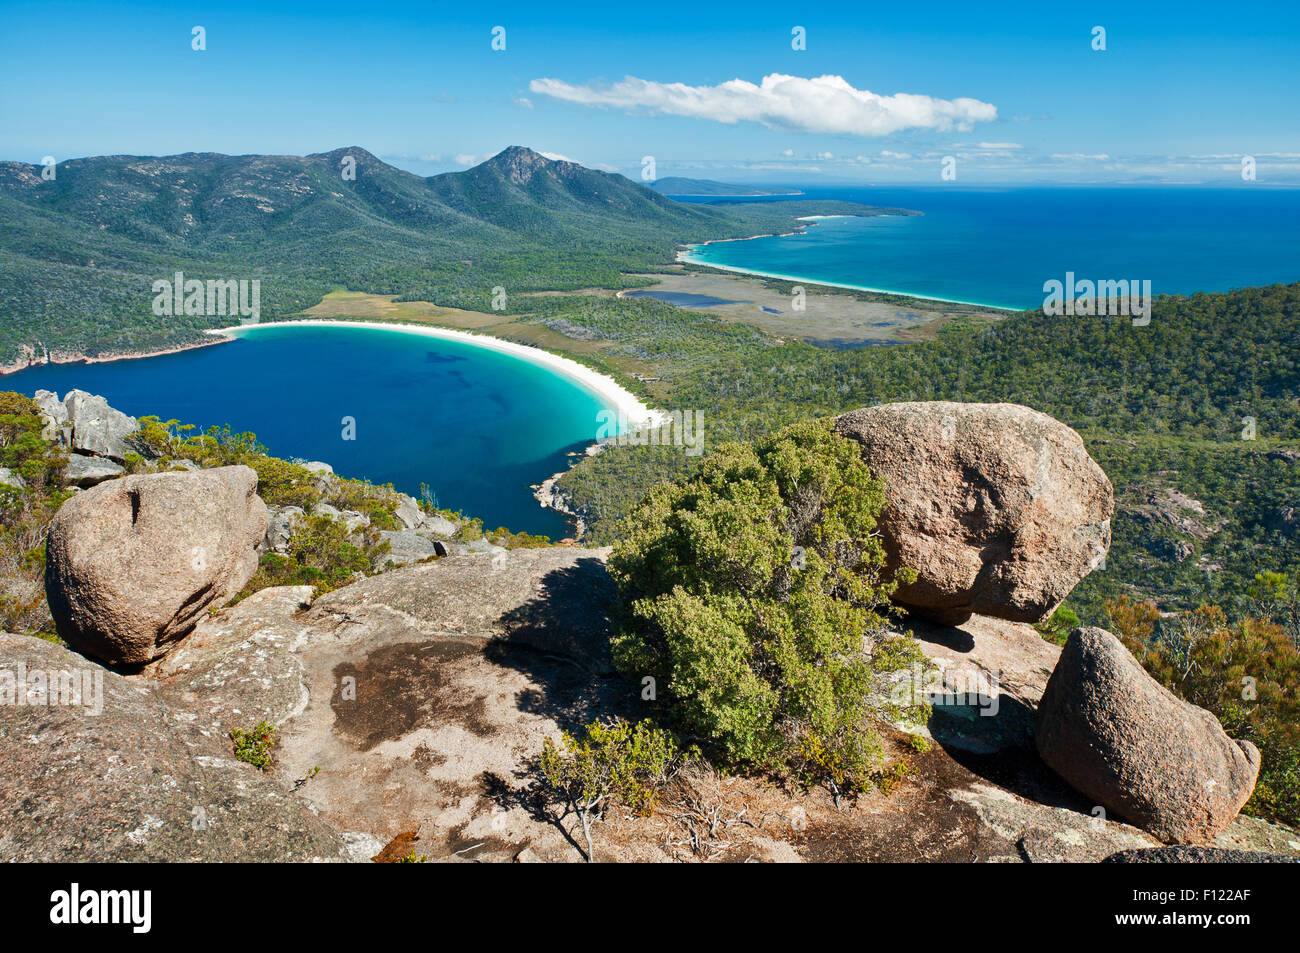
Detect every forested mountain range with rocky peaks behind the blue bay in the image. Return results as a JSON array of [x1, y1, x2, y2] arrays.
[[0, 147, 899, 364]]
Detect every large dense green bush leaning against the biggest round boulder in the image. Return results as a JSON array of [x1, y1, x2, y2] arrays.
[[610, 421, 920, 797]]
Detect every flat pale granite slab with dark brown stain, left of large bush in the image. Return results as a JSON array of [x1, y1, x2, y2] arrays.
[[144, 547, 644, 859]]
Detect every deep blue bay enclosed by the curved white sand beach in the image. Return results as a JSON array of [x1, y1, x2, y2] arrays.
[[0, 325, 608, 538]]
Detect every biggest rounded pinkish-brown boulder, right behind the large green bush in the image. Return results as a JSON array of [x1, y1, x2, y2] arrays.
[[835, 402, 1114, 624]]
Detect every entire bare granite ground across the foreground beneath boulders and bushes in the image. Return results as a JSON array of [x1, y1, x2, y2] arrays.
[[0, 546, 1300, 862]]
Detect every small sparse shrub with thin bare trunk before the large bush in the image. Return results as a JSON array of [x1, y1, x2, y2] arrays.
[[541, 719, 679, 862]]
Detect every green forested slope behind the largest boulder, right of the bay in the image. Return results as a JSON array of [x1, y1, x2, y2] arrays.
[[560, 283, 1300, 618]]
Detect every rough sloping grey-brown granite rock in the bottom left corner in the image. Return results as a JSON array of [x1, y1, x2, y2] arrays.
[[0, 633, 348, 863]]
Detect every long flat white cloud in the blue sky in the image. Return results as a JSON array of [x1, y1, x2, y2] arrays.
[[528, 73, 997, 135]]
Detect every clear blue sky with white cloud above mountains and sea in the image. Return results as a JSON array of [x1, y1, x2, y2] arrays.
[[0, 0, 1300, 186]]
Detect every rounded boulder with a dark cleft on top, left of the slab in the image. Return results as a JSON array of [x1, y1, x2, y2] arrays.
[[46, 467, 267, 664]]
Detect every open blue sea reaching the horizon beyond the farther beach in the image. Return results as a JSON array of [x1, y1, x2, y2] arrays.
[[689, 187, 1300, 308]]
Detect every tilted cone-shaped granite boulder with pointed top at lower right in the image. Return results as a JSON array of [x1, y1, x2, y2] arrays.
[[1035, 628, 1260, 844]]
